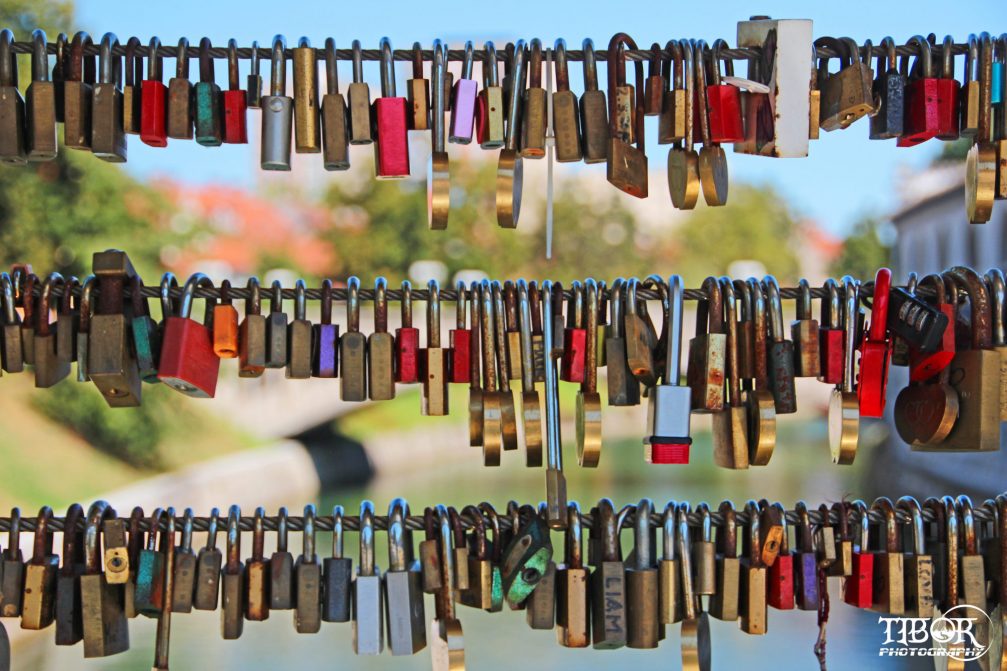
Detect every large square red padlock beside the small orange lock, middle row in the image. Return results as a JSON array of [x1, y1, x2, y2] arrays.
[[157, 273, 221, 398]]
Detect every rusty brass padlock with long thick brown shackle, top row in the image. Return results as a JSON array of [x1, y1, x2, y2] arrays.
[[606, 32, 648, 198]]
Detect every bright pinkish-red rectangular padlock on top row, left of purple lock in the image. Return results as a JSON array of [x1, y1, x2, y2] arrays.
[[374, 37, 409, 179]]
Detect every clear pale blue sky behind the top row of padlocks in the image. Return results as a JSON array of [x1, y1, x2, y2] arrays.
[[77, 0, 1007, 234]]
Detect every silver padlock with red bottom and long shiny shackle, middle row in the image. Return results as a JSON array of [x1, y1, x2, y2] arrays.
[[643, 275, 692, 463]]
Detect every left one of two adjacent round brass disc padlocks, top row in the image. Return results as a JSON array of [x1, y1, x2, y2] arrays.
[[659, 39, 700, 210]]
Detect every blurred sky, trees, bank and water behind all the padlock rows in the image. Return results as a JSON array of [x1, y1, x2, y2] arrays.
[[0, 0, 1007, 670]]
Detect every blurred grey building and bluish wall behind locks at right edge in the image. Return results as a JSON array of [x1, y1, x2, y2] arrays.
[[871, 163, 1007, 497]]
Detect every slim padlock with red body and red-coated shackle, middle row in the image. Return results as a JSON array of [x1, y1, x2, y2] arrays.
[[857, 268, 891, 417]]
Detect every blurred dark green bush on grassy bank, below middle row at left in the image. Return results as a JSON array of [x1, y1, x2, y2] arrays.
[[32, 379, 176, 469]]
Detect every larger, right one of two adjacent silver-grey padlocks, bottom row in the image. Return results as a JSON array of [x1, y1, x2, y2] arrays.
[[384, 499, 427, 655]]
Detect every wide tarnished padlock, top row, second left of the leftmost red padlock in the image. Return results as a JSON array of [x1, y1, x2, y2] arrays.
[[91, 32, 126, 163]]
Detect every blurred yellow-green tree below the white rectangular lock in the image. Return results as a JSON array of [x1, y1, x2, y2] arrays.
[[672, 184, 799, 286]]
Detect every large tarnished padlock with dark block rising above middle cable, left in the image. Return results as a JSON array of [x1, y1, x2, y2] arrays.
[[88, 250, 140, 407]]
